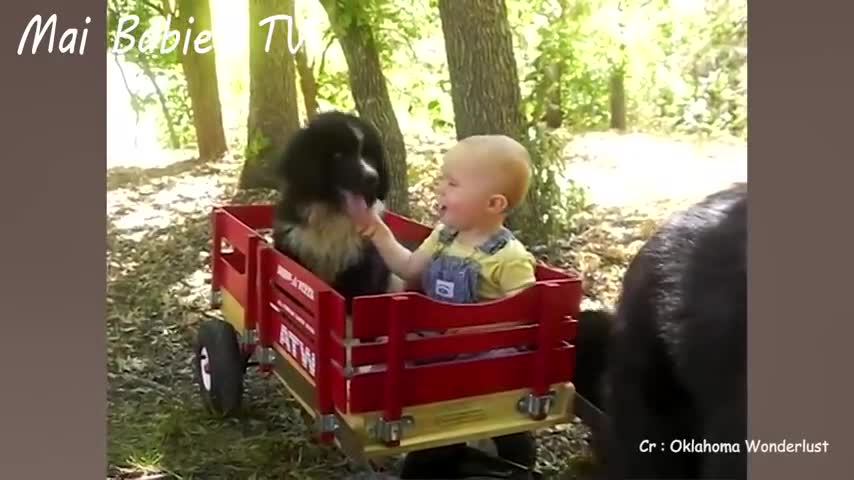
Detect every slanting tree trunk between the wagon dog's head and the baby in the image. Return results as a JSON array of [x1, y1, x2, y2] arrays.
[[321, 0, 409, 215]]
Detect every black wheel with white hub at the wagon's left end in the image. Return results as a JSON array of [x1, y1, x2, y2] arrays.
[[193, 320, 246, 416]]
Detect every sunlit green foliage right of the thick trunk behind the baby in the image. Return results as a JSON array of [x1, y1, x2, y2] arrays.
[[511, 0, 747, 136]]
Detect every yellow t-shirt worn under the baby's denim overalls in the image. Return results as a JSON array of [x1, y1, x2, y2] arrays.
[[418, 225, 536, 301]]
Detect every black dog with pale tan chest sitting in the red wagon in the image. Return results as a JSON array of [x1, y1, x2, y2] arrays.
[[273, 111, 398, 313]]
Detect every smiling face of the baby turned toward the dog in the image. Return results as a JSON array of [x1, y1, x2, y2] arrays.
[[438, 147, 497, 230]]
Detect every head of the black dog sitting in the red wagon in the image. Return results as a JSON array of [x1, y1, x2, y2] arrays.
[[278, 111, 389, 212]]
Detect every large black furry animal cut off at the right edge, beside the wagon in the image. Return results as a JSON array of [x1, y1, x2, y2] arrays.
[[577, 184, 747, 480]]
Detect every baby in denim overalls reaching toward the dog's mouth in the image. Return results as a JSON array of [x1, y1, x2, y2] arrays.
[[352, 131, 536, 330]]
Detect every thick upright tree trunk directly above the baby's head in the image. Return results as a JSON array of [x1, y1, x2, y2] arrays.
[[439, 0, 525, 141]]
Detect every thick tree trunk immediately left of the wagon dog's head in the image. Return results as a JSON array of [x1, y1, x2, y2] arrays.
[[238, 0, 300, 188]]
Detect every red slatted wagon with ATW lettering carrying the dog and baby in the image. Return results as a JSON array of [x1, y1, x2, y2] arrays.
[[196, 205, 582, 466]]
